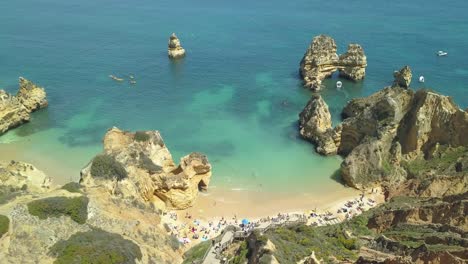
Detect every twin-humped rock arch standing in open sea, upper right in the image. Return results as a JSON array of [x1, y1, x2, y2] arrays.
[[299, 35, 367, 91]]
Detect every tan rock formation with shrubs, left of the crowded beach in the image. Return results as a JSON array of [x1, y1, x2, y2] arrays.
[[80, 127, 211, 209]]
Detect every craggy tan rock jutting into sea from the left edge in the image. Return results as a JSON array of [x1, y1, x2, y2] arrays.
[[0, 77, 47, 135]]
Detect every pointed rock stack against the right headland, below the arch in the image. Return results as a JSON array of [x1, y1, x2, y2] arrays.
[[299, 95, 340, 155]]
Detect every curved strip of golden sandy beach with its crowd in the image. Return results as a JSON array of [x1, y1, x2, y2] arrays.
[[162, 188, 384, 249]]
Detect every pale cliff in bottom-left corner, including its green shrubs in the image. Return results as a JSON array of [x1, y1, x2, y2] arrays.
[[0, 162, 182, 264]]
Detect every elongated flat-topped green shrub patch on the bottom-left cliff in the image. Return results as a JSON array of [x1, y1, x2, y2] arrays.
[[28, 196, 88, 224]]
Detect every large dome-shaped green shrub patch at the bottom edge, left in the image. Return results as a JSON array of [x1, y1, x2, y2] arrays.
[[49, 229, 142, 264]]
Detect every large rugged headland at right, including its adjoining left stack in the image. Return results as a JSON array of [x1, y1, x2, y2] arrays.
[[300, 67, 468, 188]]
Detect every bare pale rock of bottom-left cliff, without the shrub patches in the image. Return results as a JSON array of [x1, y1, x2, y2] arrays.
[[0, 162, 182, 263]]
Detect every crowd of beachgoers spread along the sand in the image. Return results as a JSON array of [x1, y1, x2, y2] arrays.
[[162, 191, 378, 246]]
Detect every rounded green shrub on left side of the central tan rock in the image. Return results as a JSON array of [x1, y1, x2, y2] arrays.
[[91, 154, 127, 181]]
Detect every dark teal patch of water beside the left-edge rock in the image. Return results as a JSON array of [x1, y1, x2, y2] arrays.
[[14, 108, 56, 137]]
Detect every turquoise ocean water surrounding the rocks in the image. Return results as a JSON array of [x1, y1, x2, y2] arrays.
[[0, 0, 468, 191]]
